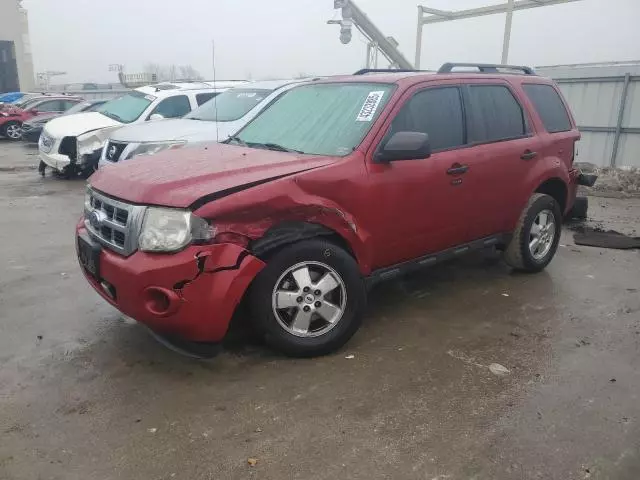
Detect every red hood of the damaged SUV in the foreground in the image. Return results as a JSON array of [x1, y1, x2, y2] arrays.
[[90, 143, 339, 208]]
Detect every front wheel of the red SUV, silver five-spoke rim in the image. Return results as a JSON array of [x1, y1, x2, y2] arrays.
[[250, 239, 366, 357]]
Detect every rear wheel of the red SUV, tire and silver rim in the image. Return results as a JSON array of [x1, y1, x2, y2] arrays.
[[504, 193, 562, 273]]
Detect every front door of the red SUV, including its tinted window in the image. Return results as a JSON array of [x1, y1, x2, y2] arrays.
[[368, 83, 478, 268]]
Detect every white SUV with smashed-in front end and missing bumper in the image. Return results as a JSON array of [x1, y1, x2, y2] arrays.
[[38, 81, 246, 176]]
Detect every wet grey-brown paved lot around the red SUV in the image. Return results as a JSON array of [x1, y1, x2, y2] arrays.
[[0, 141, 640, 480]]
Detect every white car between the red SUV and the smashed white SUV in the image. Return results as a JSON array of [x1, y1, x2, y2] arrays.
[[100, 79, 316, 166]]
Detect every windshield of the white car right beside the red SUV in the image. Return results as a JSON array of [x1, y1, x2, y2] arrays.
[[184, 88, 271, 122]]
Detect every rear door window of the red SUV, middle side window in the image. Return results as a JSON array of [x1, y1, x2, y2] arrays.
[[468, 85, 527, 143]]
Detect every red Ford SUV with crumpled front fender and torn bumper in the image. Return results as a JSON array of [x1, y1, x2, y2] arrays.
[[77, 64, 593, 356]]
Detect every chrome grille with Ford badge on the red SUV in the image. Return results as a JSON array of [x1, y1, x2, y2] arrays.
[[84, 189, 145, 256]]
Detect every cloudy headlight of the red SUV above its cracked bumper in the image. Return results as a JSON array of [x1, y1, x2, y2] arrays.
[[138, 207, 214, 252]]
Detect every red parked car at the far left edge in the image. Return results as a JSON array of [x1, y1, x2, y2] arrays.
[[0, 95, 82, 140]]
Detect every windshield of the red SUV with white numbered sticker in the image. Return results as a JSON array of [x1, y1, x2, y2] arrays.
[[232, 83, 393, 156]]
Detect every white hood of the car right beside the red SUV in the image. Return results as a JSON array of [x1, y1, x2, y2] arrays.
[[110, 118, 240, 143]]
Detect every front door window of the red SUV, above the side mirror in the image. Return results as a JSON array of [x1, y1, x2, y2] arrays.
[[391, 87, 467, 151]]
